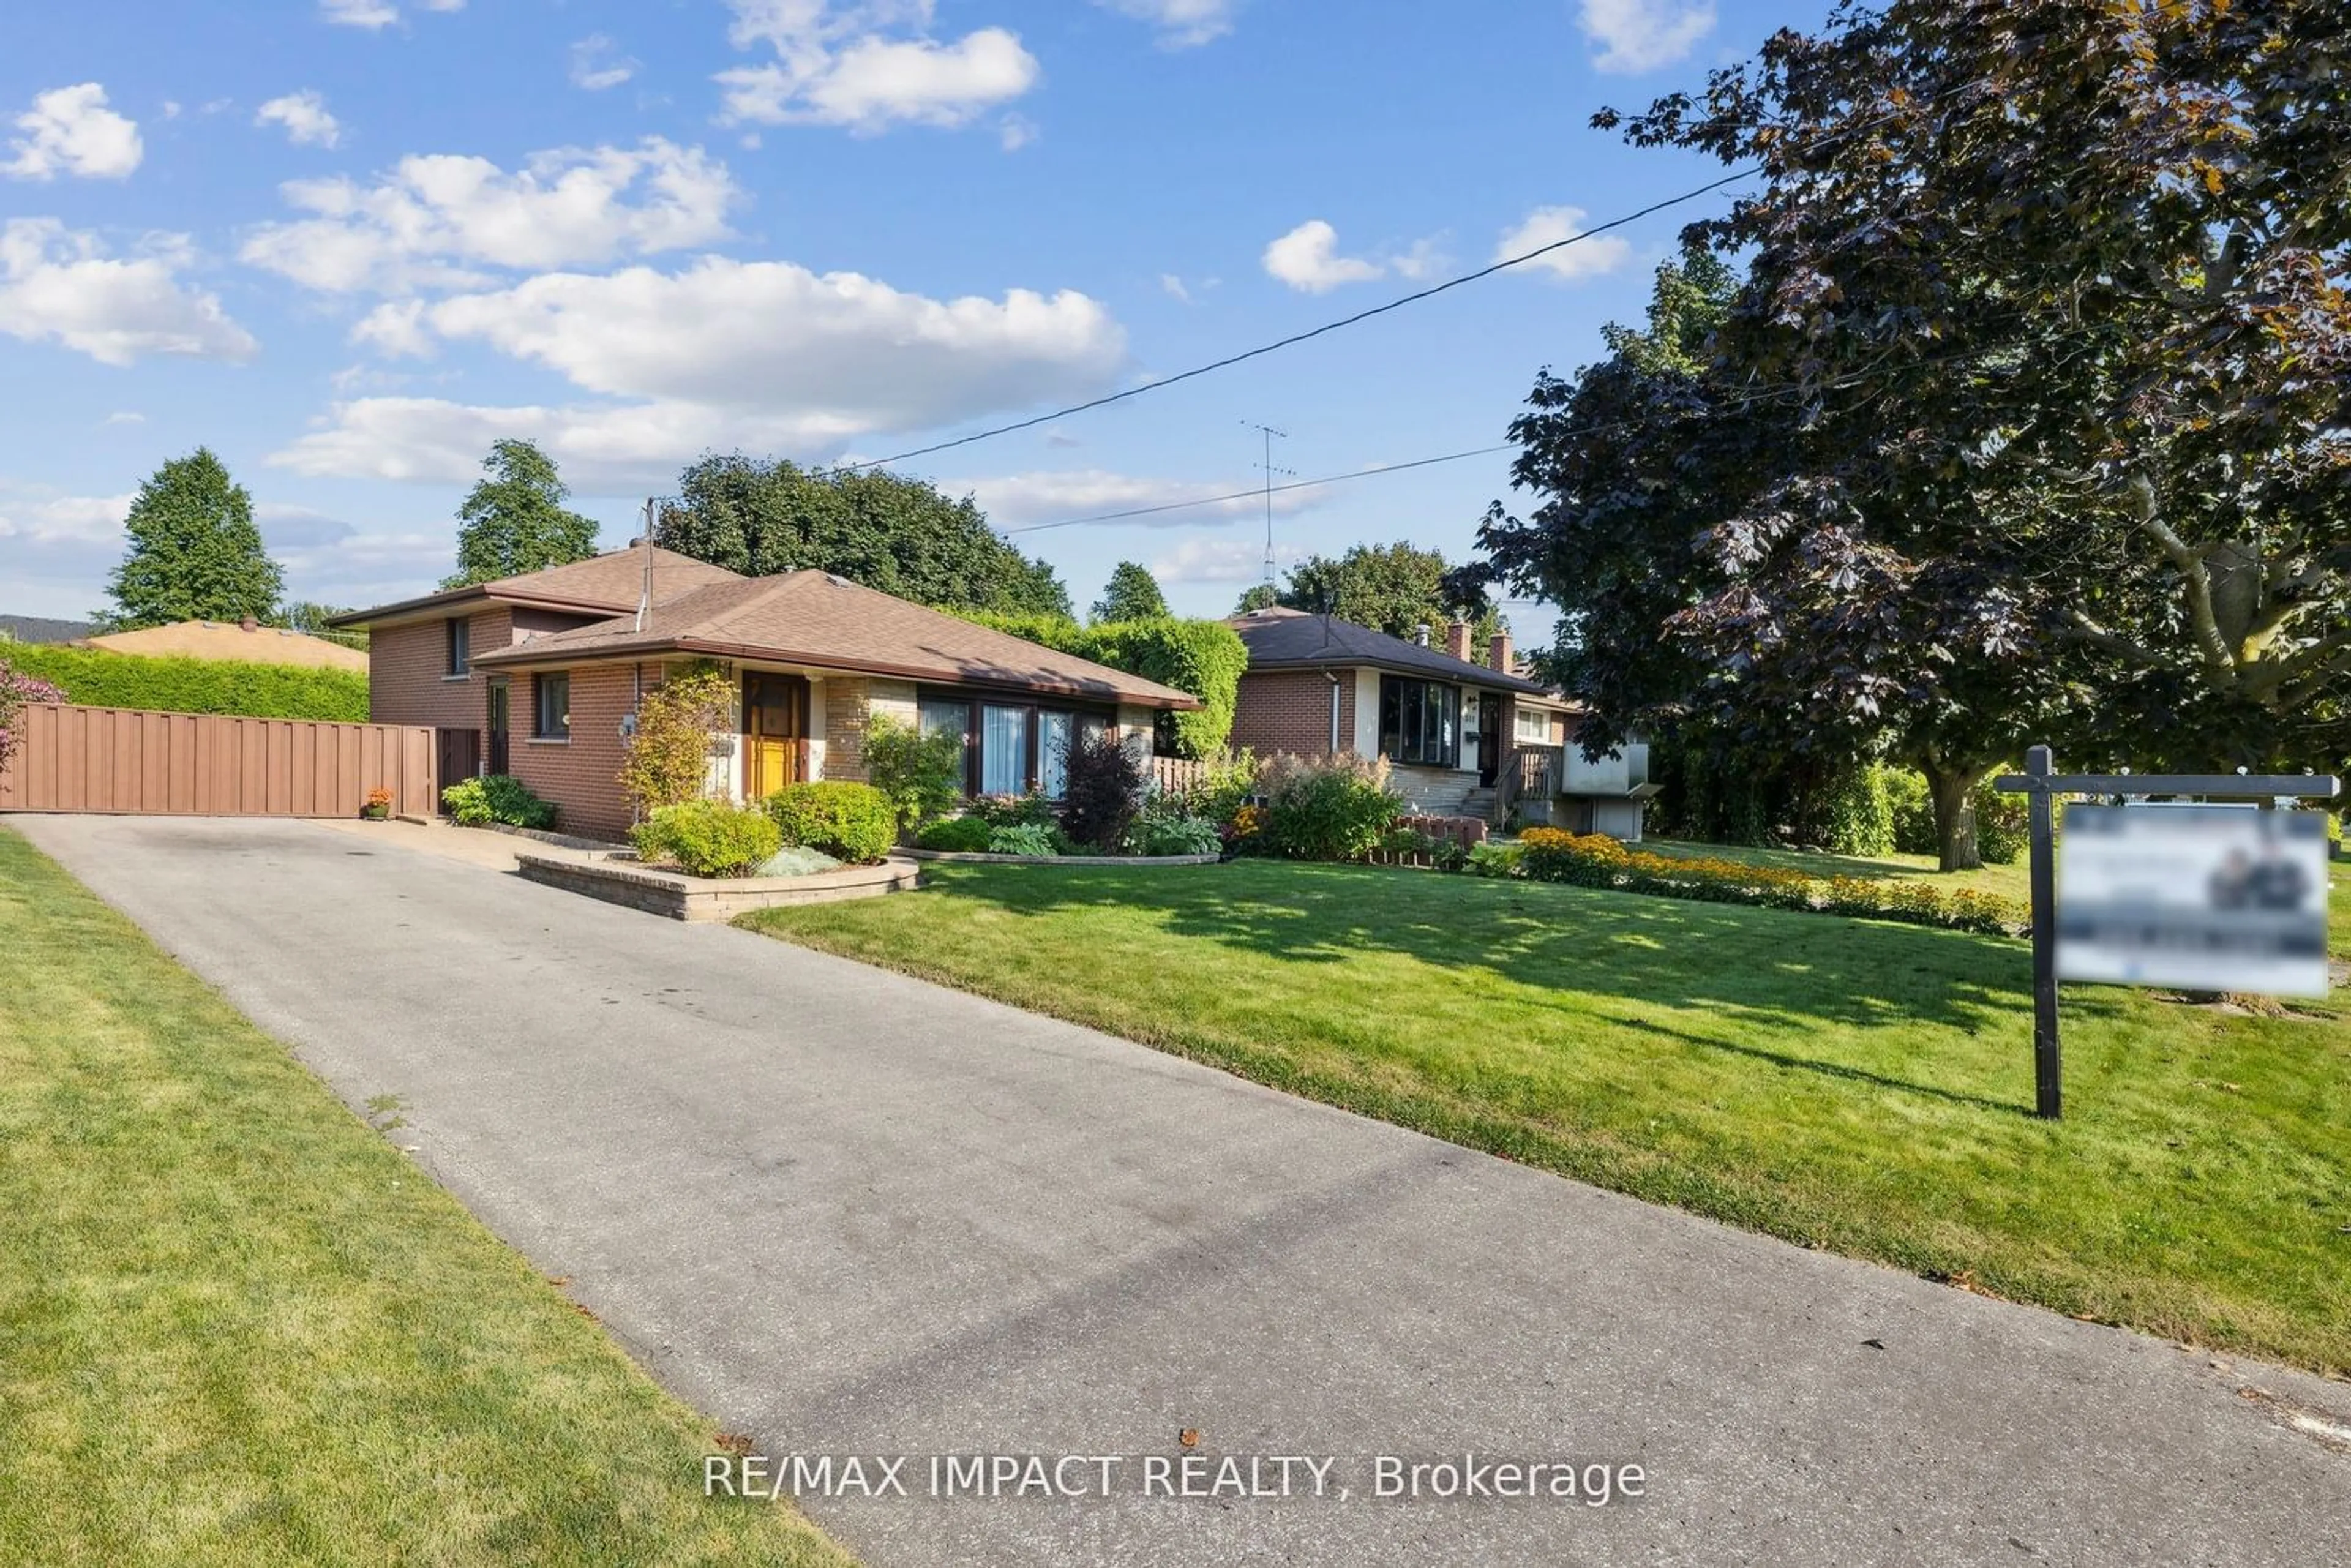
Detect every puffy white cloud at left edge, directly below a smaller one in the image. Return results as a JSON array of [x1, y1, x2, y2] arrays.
[[0, 219, 258, 364]]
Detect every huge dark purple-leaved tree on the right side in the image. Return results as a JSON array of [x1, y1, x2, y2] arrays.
[[1488, 0, 2351, 865]]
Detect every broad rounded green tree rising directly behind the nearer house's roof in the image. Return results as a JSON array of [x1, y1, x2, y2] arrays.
[[654, 454, 1072, 616]]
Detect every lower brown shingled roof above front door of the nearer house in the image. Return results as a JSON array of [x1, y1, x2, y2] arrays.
[[473, 571, 1201, 708]]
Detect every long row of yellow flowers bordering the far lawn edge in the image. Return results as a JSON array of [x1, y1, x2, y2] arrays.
[[1519, 828, 2029, 936]]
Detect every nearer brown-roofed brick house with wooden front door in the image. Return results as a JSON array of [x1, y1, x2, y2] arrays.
[[336, 546, 1199, 837]]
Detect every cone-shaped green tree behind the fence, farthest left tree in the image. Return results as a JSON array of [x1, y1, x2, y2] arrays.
[[101, 447, 285, 630]]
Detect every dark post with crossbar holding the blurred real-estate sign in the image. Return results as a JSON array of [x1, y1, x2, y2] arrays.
[[1991, 745, 2342, 1121]]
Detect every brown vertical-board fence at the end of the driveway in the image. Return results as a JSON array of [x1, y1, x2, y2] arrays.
[[0, 703, 435, 816]]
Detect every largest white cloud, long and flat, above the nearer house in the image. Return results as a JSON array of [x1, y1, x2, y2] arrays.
[[271, 257, 1126, 493]]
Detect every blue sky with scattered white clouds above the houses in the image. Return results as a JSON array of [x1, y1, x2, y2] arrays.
[[0, 0, 1817, 635]]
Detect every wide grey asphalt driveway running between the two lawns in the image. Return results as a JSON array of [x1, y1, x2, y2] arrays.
[[12, 818, 2351, 1568]]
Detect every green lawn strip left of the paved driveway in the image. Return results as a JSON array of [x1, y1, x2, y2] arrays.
[[0, 832, 846, 1568]]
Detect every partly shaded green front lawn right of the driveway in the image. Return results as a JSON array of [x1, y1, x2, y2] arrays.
[[743, 860, 2351, 1373]]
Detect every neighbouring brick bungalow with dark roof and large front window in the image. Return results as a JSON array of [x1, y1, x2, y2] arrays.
[[1229, 607, 1575, 818]]
